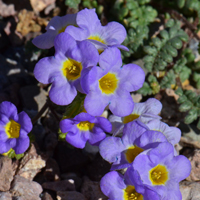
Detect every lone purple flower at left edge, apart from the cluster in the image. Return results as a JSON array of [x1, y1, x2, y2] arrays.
[[0, 101, 32, 154]]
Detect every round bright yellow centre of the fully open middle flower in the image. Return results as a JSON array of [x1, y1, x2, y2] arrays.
[[99, 73, 118, 94]]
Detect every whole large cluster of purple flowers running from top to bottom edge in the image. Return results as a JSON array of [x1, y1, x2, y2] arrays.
[[33, 9, 191, 200]]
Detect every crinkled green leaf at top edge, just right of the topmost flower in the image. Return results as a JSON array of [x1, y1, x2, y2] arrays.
[[110, 0, 157, 57]]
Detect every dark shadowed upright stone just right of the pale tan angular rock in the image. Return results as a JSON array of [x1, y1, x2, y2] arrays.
[[44, 158, 60, 181]]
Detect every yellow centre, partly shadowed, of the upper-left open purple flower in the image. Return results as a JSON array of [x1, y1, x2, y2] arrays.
[[62, 59, 82, 81]]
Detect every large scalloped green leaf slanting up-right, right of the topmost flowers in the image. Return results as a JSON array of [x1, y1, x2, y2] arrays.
[[143, 19, 188, 72]]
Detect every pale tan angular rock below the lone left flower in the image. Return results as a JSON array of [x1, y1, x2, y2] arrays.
[[17, 144, 46, 181]]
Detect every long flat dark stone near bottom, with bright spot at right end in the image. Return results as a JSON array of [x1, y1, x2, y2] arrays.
[[42, 179, 75, 192]]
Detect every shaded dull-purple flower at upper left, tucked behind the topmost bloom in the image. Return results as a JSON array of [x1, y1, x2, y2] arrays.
[[32, 14, 77, 49]]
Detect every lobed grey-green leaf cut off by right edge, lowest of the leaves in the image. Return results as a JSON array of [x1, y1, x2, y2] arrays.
[[175, 88, 200, 129]]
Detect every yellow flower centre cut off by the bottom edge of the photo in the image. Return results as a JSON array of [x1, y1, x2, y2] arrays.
[[124, 185, 143, 200]]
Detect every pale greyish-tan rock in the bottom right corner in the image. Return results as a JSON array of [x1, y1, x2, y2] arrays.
[[180, 181, 200, 200]]
